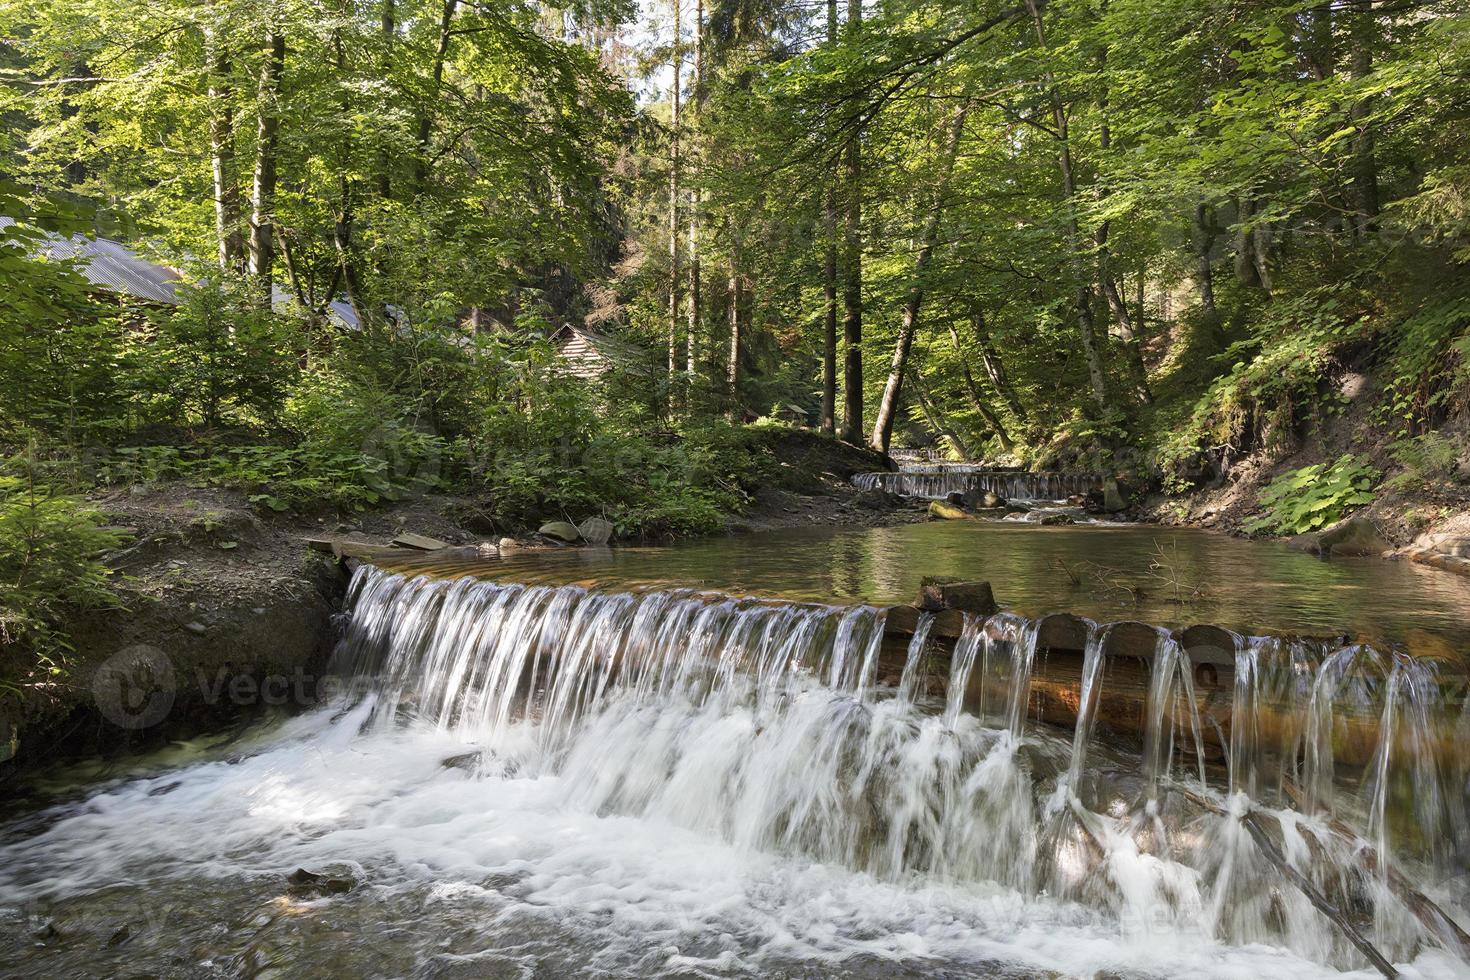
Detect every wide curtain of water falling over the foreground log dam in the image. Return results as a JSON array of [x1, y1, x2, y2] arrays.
[[330, 569, 1467, 973]]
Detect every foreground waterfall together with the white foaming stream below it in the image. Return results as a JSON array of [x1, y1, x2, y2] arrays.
[[0, 529, 1470, 979]]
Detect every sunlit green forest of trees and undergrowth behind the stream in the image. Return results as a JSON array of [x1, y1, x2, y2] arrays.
[[0, 0, 1470, 696]]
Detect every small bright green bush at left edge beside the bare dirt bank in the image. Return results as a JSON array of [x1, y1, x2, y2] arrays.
[[0, 457, 125, 696]]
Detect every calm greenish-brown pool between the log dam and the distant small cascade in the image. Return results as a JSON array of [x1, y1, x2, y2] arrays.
[[382, 522, 1470, 652]]
